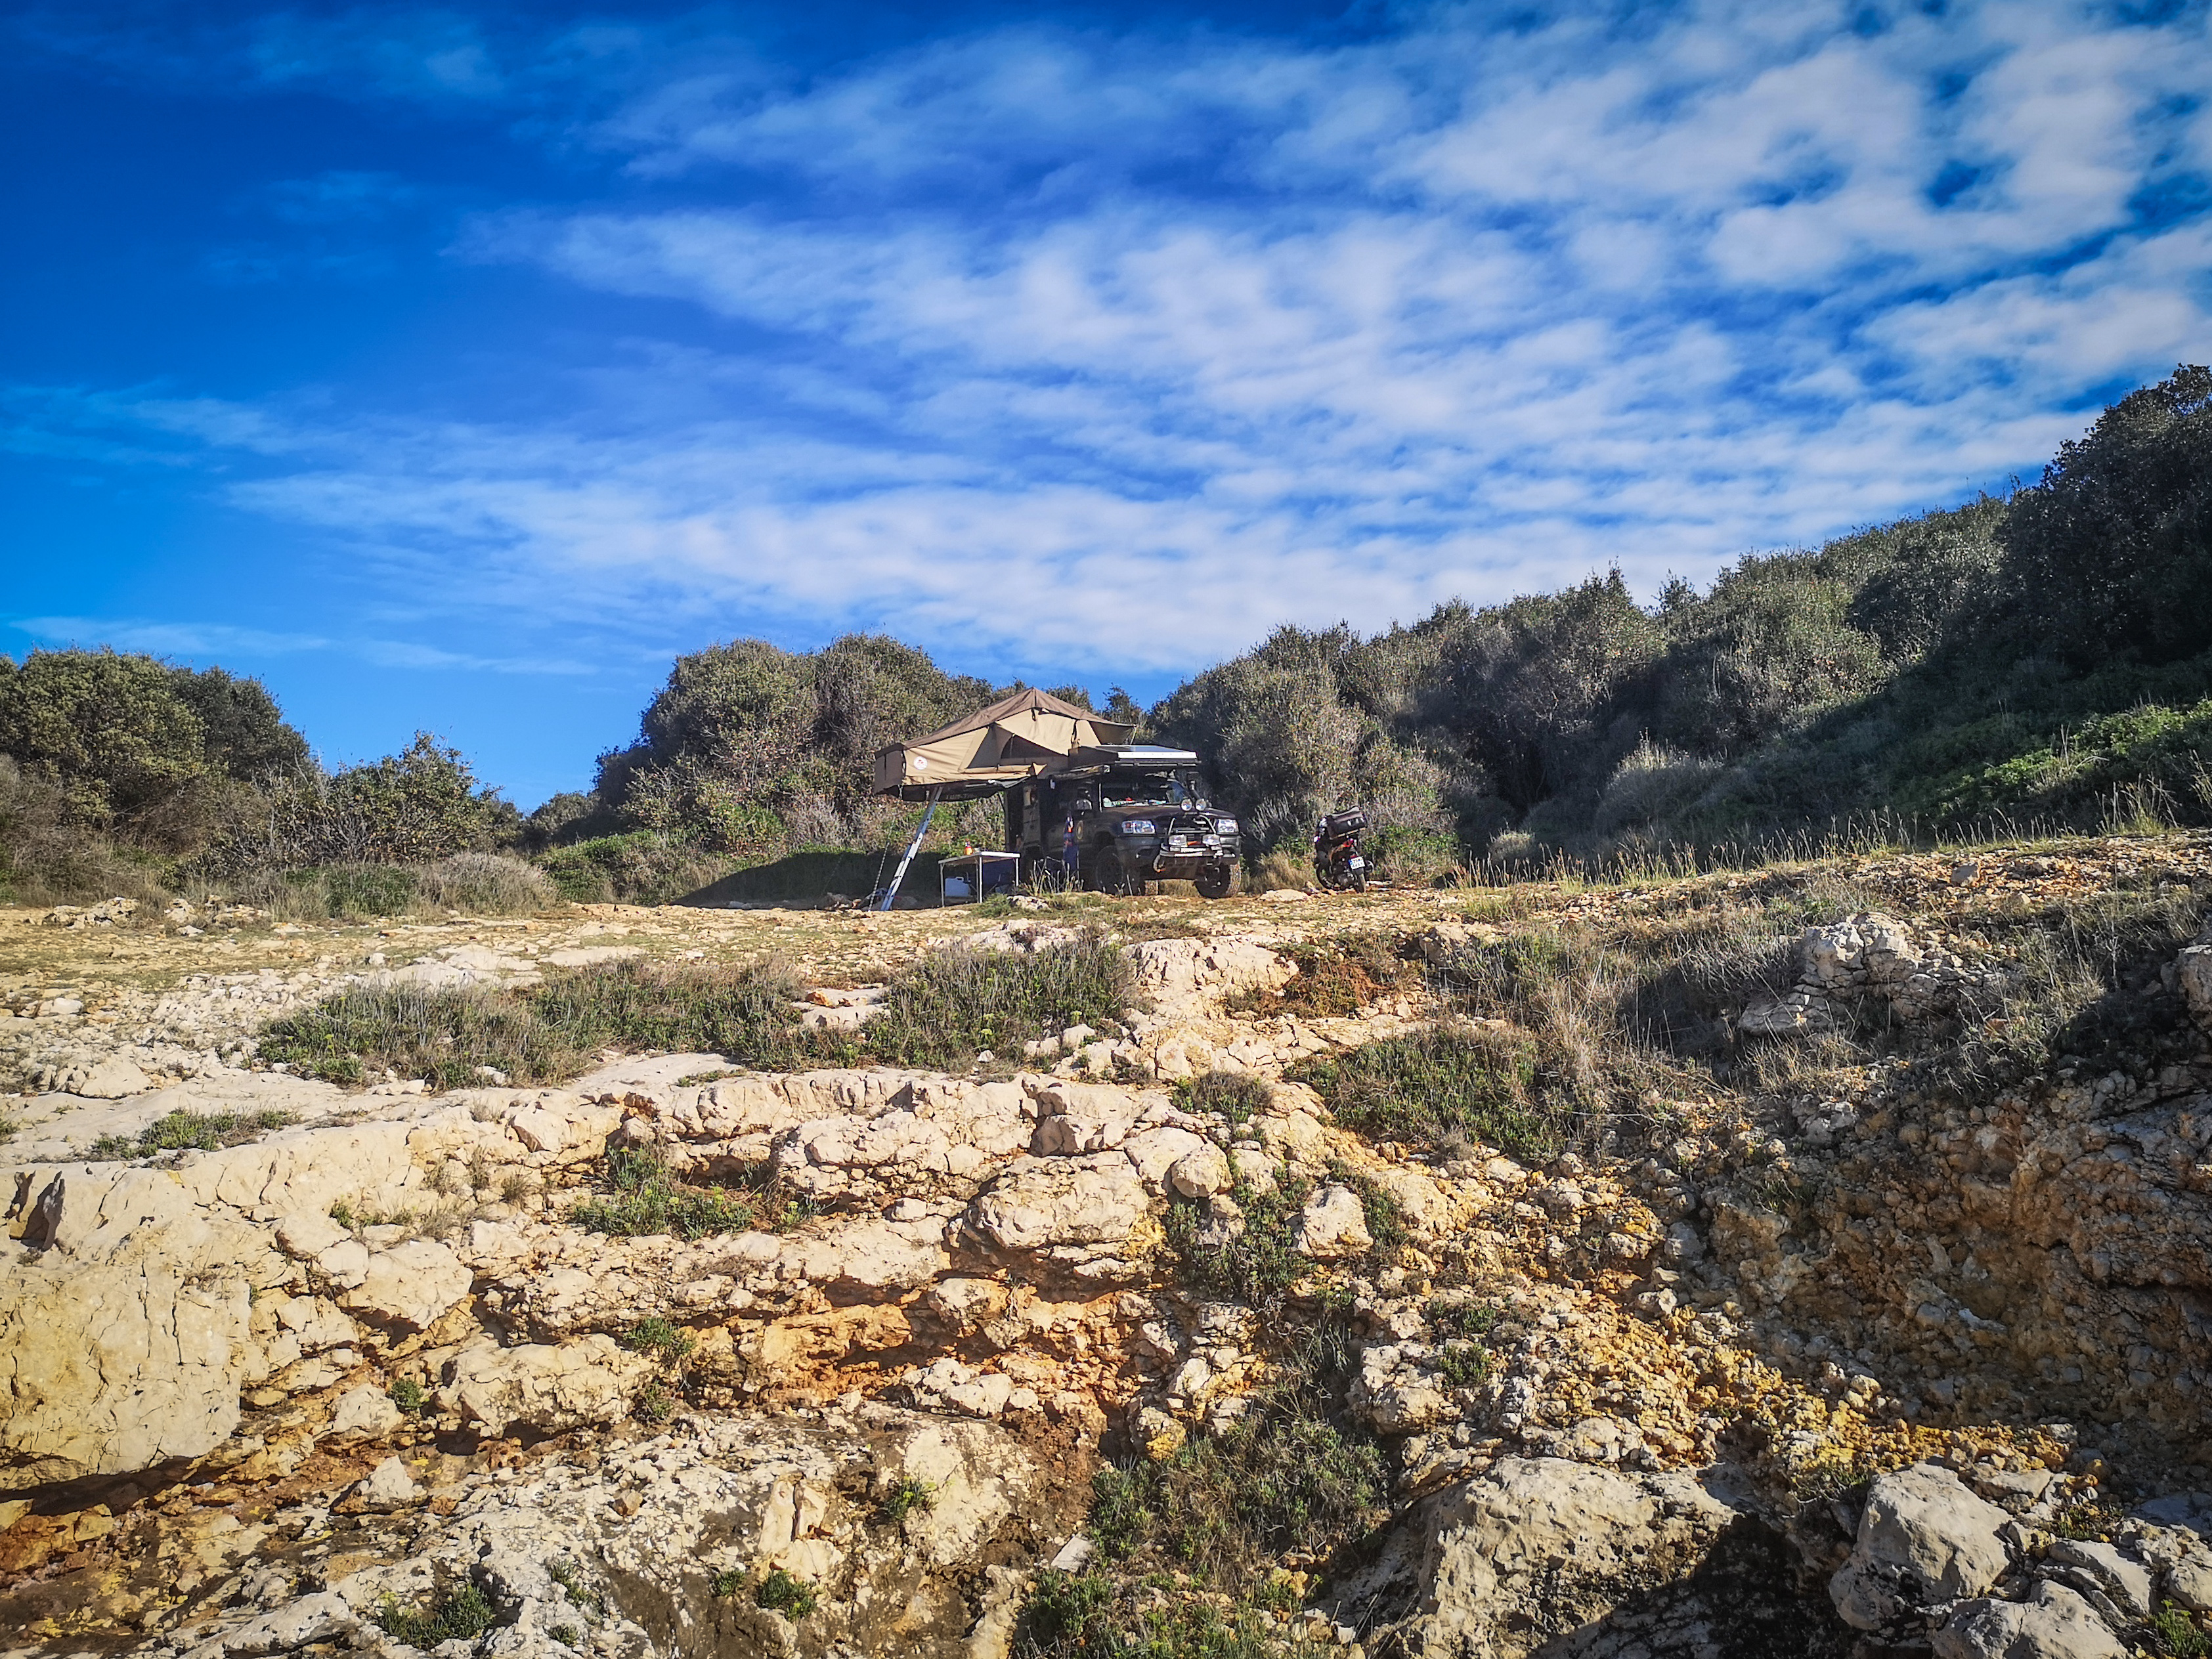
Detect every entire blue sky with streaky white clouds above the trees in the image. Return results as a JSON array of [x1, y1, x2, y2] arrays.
[[0, 0, 2212, 805]]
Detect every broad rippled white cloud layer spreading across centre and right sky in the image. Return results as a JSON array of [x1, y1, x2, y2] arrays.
[[9, 0, 2212, 690]]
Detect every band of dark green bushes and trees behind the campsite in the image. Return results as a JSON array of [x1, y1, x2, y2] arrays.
[[0, 367, 2212, 909]]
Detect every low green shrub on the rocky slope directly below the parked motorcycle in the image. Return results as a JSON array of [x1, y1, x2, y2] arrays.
[[1291, 1024, 1566, 1163]]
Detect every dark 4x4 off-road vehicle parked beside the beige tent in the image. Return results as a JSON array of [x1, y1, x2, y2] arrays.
[[1007, 743, 1243, 898]]
